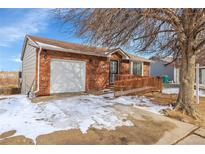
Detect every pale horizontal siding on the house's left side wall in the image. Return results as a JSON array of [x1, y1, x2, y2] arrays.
[[21, 41, 36, 94]]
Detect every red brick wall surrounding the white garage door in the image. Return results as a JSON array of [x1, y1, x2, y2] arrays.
[[37, 50, 109, 96]]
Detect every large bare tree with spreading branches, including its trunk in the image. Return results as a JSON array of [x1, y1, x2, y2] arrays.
[[57, 8, 205, 117]]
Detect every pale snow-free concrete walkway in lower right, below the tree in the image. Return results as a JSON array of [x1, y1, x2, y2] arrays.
[[115, 105, 201, 144]]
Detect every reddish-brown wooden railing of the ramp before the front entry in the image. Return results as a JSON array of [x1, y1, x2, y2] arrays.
[[114, 75, 162, 96]]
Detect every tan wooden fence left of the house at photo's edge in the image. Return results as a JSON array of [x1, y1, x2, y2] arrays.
[[0, 72, 19, 87]]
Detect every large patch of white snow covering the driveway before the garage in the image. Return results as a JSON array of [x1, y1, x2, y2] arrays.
[[0, 94, 168, 141]]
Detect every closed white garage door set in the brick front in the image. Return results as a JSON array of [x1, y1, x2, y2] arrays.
[[50, 59, 86, 94]]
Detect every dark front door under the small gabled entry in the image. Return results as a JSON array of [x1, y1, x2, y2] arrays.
[[110, 60, 118, 84]]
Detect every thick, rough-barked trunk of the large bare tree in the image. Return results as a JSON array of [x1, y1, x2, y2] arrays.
[[175, 55, 197, 118]]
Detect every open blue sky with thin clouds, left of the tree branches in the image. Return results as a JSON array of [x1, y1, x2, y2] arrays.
[[0, 9, 82, 71]]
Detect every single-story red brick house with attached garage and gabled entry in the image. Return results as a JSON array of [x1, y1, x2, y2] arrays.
[[21, 35, 151, 96]]
